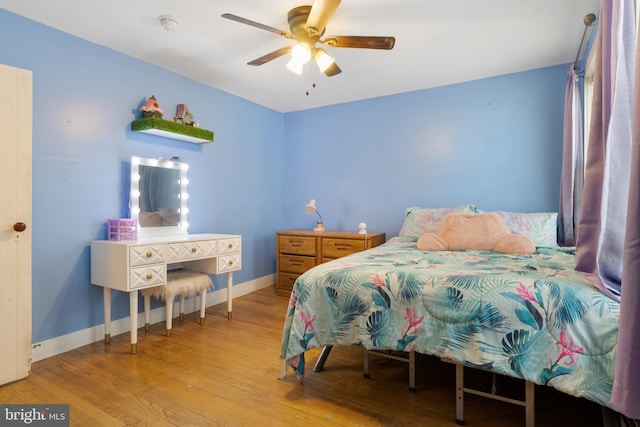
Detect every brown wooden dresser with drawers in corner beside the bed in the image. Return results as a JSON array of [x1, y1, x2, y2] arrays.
[[276, 229, 386, 297]]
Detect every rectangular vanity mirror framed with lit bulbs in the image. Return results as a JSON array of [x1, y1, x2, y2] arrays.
[[129, 156, 189, 238]]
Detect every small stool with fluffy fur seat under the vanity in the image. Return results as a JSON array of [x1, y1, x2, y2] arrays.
[[140, 270, 213, 337]]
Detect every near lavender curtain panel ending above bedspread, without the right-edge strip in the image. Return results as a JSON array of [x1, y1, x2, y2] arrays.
[[576, 0, 636, 298]]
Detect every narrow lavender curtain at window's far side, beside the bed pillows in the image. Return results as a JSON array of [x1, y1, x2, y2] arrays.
[[558, 64, 584, 246]]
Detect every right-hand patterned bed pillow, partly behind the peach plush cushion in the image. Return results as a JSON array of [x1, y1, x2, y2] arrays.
[[496, 211, 558, 246]]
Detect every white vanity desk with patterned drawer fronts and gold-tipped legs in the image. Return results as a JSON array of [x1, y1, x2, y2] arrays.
[[91, 234, 242, 354]]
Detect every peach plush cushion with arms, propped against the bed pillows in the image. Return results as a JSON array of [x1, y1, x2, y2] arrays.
[[417, 213, 536, 255]]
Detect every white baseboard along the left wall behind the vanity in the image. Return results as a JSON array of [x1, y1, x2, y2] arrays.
[[31, 274, 275, 362]]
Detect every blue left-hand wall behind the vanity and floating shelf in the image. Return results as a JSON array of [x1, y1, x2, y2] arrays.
[[0, 9, 284, 342]]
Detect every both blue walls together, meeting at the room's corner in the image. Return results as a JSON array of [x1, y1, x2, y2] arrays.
[[0, 9, 566, 342]]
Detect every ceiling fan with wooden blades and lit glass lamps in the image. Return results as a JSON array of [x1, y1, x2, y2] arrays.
[[222, 0, 396, 77]]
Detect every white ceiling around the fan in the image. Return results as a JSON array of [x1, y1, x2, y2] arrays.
[[0, 0, 600, 112]]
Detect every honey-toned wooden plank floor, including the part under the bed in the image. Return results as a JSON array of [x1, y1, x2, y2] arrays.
[[0, 288, 602, 427]]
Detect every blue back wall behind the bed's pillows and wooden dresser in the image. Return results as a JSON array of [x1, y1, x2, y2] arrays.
[[284, 65, 567, 237]]
